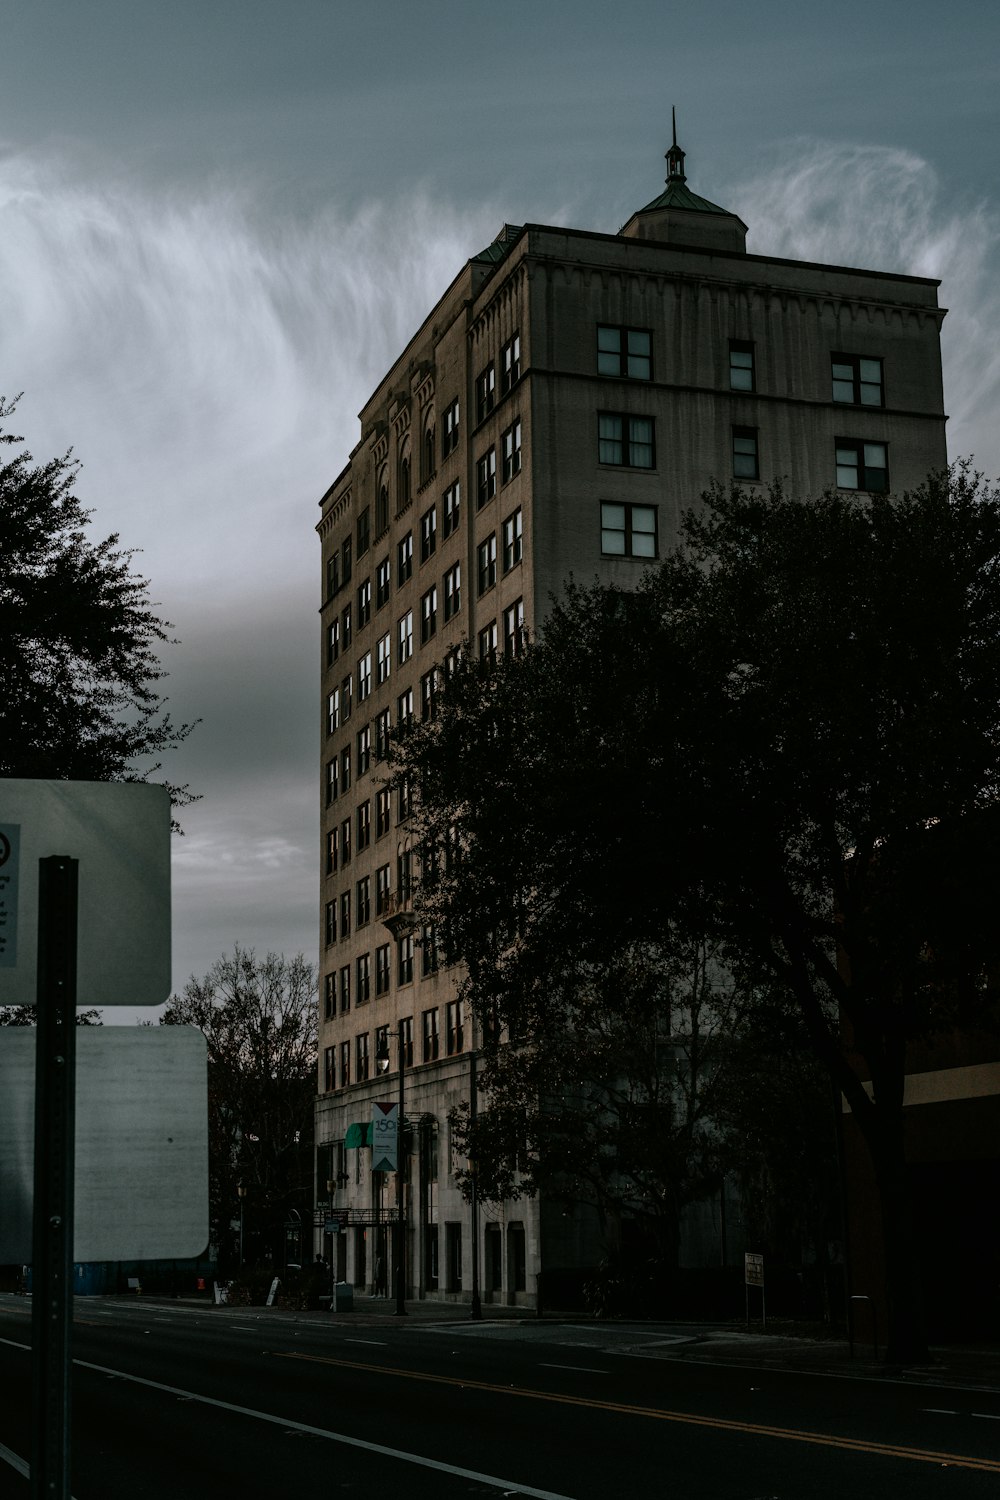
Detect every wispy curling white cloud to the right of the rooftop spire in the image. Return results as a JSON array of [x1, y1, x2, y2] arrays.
[[724, 141, 1000, 476]]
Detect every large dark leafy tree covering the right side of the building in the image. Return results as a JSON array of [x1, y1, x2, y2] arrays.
[[397, 467, 1000, 1359]]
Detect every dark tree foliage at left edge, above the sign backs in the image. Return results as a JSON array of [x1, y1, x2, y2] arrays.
[[0, 398, 192, 803]]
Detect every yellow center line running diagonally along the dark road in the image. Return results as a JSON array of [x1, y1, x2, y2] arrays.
[[267, 1350, 1000, 1475]]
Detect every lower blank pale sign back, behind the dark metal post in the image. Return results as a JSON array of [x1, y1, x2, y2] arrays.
[[0, 1026, 208, 1265]]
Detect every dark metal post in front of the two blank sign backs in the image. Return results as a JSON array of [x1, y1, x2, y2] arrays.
[[31, 855, 78, 1500]]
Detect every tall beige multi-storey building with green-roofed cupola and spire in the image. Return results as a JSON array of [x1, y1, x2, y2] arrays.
[[316, 143, 946, 1305]]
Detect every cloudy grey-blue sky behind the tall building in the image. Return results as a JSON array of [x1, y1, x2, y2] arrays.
[[0, 0, 1000, 1019]]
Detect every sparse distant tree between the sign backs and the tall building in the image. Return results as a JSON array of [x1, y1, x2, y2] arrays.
[[160, 945, 316, 1268]]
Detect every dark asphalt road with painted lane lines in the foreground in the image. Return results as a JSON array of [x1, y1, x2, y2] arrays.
[[0, 1298, 1000, 1500]]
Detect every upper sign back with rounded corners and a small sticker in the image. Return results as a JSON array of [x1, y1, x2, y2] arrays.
[[0, 779, 171, 1007]]
